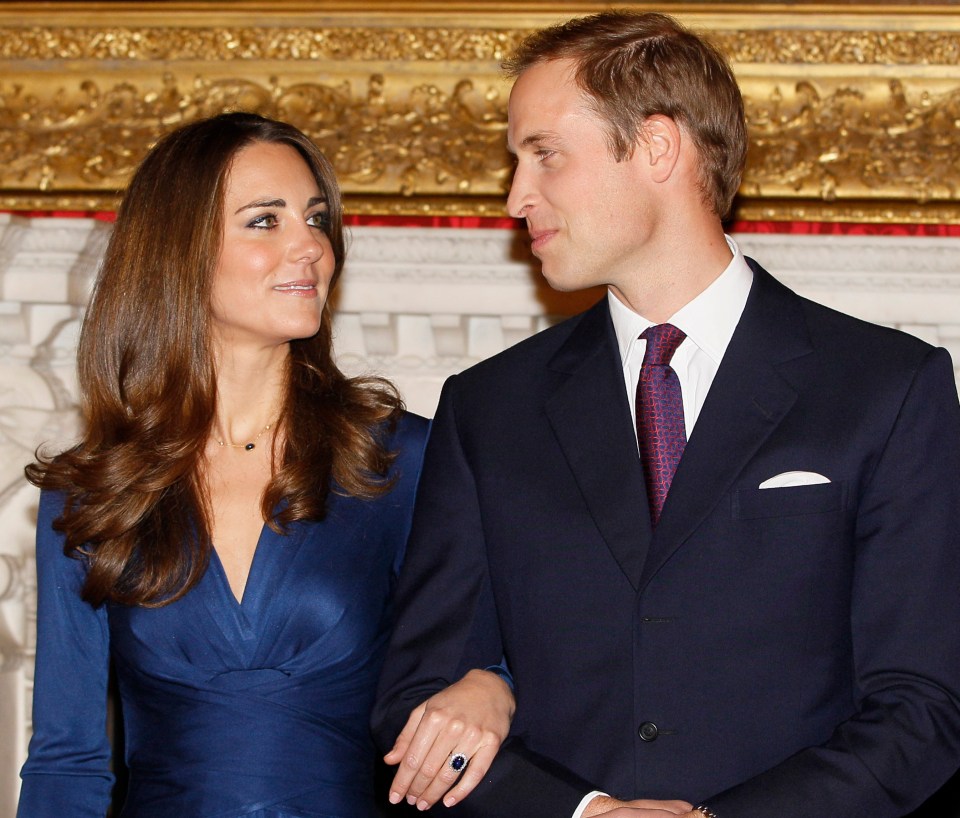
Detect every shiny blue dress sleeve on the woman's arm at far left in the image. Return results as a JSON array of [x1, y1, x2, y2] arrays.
[[17, 492, 113, 818]]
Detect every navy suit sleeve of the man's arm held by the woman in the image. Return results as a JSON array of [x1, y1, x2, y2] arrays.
[[373, 377, 594, 818]]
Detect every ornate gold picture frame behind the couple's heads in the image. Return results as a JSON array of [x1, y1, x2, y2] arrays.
[[0, 0, 960, 224]]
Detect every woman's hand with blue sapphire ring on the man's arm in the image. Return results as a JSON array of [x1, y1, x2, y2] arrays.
[[384, 670, 516, 810]]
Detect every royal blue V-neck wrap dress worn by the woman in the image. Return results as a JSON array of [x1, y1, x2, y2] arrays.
[[17, 415, 427, 818]]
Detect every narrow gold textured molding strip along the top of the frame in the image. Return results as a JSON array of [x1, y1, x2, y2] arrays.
[[9, 18, 960, 67]]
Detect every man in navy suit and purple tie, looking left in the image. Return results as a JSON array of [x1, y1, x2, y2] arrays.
[[375, 13, 960, 818]]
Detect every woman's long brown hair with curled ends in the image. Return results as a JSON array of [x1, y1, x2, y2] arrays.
[[26, 113, 402, 606]]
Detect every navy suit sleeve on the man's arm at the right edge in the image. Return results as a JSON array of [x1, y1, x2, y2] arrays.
[[706, 349, 960, 818]]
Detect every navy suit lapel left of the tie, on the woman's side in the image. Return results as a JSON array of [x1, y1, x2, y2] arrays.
[[546, 298, 651, 588]]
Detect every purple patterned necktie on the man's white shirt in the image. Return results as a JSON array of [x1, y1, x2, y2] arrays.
[[637, 324, 687, 525]]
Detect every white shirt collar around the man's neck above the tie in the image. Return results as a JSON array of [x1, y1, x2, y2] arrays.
[[607, 236, 753, 364]]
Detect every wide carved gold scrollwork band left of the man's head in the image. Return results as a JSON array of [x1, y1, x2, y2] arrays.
[[0, 73, 509, 197]]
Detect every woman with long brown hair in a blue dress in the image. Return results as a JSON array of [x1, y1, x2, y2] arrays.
[[18, 114, 510, 818]]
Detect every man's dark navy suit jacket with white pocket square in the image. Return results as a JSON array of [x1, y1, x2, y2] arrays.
[[374, 262, 960, 818]]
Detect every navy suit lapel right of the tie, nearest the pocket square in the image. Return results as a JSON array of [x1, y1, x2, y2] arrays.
[[640, 261, 812, 589]]
